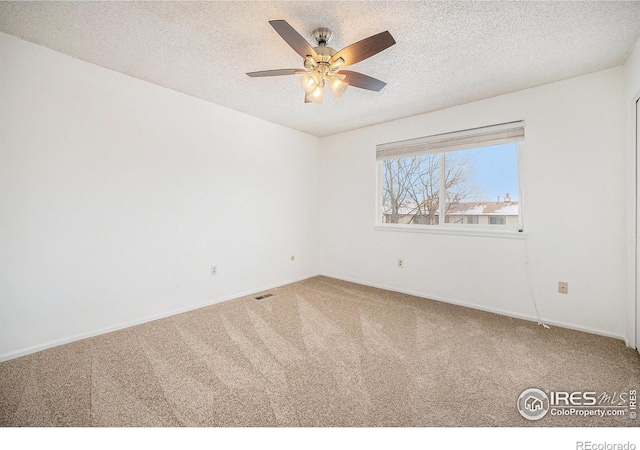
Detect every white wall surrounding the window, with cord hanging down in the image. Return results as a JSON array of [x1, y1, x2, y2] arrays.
[[320, 67, 627, 338]]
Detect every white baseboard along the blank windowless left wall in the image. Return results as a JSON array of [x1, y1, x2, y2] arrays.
[[0, 274, 318, 362]]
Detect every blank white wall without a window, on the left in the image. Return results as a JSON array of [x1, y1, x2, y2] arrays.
[[0, 34, 319, 360]]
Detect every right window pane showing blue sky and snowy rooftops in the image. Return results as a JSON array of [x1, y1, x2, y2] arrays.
[[444, 143, 519, 225]]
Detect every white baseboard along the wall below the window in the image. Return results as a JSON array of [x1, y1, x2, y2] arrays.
[[320, 273, 626, 342]]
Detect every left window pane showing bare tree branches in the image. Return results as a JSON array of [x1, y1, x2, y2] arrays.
[[382, 154, 440, 225]]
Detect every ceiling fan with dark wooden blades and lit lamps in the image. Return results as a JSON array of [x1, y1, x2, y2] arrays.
[[247, 20, 396, 103]]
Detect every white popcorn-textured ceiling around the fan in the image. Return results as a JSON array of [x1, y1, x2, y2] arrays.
[[0, 1, 640, 136]]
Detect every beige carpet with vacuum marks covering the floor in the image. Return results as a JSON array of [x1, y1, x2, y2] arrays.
[[0, 277, 640, 427]]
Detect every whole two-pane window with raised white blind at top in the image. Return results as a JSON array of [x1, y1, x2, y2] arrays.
[[376, 122, 524, 230]]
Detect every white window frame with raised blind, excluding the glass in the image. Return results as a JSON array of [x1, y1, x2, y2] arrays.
[[374, 121, 526, 238]]
